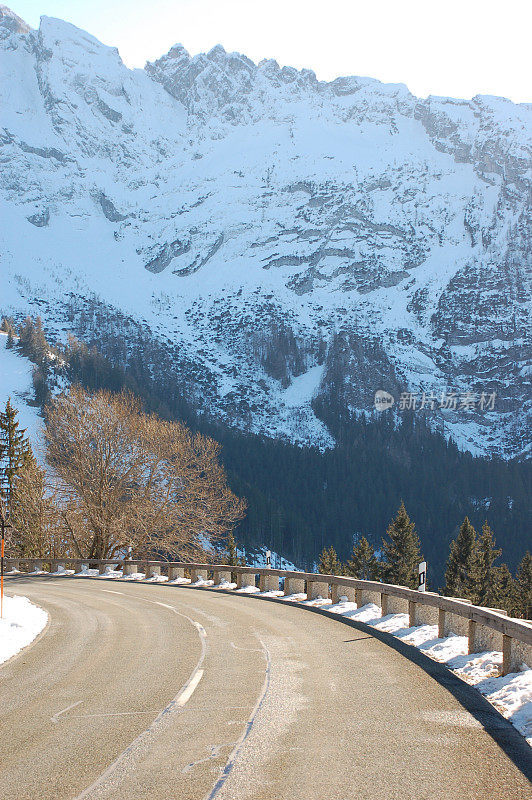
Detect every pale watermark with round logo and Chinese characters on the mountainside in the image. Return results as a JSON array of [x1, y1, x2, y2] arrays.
[[374, 389, 497, 411]]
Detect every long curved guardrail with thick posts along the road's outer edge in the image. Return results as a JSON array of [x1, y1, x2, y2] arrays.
[[5, 558, 532, 675]]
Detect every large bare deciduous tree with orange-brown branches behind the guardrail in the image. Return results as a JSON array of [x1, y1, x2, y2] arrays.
[[45, 386, 245, 559]]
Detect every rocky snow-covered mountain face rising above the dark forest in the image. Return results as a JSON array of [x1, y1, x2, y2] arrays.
[[0, 7, 532, 458]]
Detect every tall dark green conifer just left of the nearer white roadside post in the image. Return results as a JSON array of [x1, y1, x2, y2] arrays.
[[382, 501, 422, 589]]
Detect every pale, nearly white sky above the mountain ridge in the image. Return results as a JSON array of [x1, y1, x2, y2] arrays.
[[7, 0, 532, 103]]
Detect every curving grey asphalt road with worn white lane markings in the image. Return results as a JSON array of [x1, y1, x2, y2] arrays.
[[0, 576, 532, 800]]
